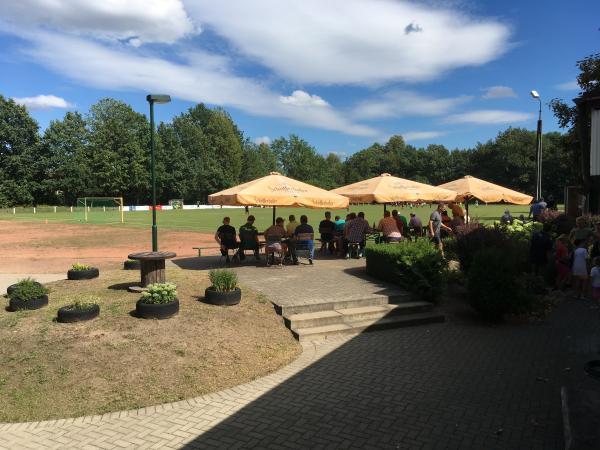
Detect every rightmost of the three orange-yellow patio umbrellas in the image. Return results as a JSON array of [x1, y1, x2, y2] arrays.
[[438, 175, 533, 222]]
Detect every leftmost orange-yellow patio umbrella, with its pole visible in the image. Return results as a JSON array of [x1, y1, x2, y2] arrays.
[[208, 172, 349, 223]]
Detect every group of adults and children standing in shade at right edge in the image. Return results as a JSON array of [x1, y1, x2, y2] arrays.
[[530, 217, 600, 300]]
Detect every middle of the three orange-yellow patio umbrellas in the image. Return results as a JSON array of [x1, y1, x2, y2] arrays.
[[331, 173, 456, 204]]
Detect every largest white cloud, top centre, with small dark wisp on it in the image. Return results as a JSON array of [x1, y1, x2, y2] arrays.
[[184, 0, 510, 84]]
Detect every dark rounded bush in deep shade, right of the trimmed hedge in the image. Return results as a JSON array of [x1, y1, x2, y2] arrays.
[[467, 247, 545, 322]]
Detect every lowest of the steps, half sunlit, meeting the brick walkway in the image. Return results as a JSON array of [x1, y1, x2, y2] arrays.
[[292, 312, 446, 342]]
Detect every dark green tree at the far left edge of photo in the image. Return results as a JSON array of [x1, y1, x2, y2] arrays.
[[0, 95, 40, 207]]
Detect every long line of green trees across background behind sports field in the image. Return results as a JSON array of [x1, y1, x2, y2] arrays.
[[0, 95, 579, 207]]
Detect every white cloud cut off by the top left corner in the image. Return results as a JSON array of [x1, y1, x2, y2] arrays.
[[0, 0, 197, 46]]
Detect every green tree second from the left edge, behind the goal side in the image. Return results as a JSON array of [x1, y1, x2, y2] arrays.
[[42, 112, 92, 205]]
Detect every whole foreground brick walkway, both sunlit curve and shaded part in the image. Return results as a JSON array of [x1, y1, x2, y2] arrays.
[[0, 290, 600, 449]]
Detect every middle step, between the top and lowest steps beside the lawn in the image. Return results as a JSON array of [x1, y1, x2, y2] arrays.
[[284, 302, 433, 330]]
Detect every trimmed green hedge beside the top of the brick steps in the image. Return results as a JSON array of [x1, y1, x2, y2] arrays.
[[366, 239, 448, 301]]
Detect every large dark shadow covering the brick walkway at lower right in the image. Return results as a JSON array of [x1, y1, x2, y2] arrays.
[[179, 302, 600, 450]]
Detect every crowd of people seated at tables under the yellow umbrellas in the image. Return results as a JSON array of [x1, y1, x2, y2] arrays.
[[215, 203, 465, 264]]
